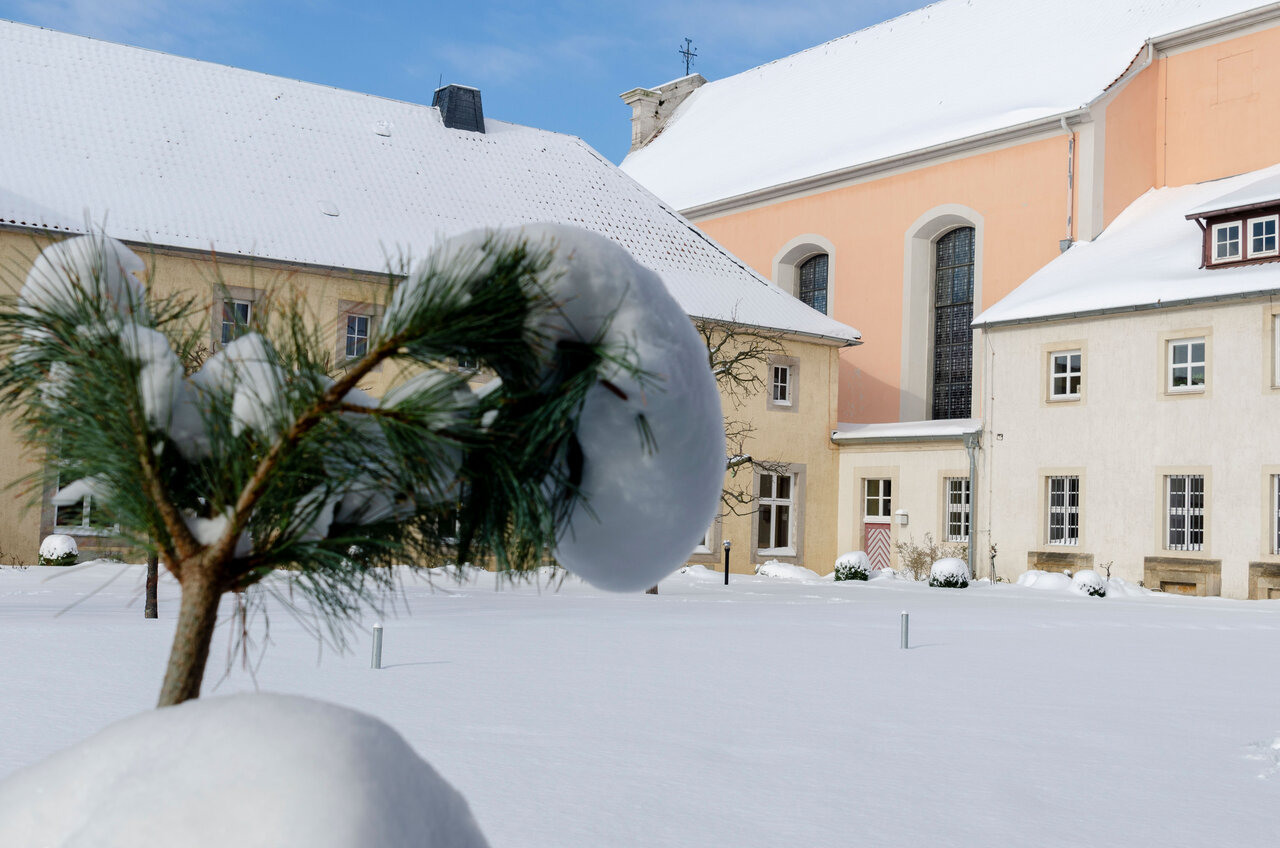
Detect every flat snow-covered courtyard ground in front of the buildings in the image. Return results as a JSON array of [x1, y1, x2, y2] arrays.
[[0, 565, 1280, 848]]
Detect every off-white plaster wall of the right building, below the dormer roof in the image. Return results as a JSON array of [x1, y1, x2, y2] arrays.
[[979, 298, 1280, 598]]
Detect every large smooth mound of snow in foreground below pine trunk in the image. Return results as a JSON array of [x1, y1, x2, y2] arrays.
[[0, 694, 488, 848]]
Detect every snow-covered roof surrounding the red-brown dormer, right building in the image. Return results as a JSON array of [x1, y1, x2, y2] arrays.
[[974, 165, 1280, 327]]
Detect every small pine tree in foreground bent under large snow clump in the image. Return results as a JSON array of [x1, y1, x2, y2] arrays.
[[0, 224, 724, 703]]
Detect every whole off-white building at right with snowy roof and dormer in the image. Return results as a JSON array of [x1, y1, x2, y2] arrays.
[[977, 167, 1280, 598]]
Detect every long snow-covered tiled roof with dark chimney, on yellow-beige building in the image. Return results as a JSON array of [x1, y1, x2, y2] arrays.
[[0, 22, 859, 342]]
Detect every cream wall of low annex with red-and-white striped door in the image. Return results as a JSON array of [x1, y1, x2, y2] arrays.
[[836, 439, 984, 575]]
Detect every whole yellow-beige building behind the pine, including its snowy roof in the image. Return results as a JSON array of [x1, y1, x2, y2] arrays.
[[0, 22, 860, 570]]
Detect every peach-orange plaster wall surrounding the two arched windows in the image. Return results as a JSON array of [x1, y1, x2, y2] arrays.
[[698, 133, 1068, 421]]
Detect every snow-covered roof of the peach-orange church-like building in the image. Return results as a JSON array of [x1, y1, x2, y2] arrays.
[[622, 0, 1268, 210]]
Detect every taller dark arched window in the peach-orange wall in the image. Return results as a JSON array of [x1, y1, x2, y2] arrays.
[[933, 227, 974, 419]]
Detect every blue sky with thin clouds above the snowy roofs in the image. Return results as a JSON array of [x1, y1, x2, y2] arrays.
[[0, 0, 925, 161]]
